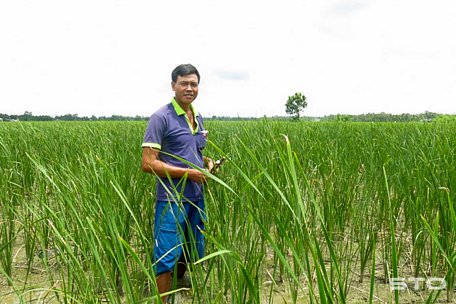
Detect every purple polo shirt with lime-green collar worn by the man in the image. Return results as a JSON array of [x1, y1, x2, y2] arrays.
[[142, 98, 206, 202]]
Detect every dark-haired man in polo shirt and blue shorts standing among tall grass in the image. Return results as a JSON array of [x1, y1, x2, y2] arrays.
[[142, 64, 213, 303]]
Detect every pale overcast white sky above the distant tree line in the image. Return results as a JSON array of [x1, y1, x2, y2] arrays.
[[0, 0, 456, 116]]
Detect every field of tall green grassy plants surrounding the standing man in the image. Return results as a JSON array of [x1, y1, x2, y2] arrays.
[[0, 120, 456, 303]]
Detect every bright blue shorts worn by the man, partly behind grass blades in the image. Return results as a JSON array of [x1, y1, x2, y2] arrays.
[[154, 200, 206, 276]]
